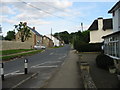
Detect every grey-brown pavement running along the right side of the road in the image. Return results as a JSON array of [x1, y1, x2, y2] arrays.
[[44, 50, 84, 88]]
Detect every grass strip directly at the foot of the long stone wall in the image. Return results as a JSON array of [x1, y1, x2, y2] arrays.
[[0, 49, 34, 55]]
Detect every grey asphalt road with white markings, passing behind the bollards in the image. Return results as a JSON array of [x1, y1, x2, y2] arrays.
[[4, 45, 70, 88]]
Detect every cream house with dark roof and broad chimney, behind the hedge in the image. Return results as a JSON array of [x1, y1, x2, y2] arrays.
[[88, 18, 113, 43]]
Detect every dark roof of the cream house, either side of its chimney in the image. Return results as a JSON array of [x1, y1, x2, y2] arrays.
[[88, 18, 113, 31]]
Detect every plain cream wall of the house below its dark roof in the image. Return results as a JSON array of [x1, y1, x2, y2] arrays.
[[90, 29, 113, 43]]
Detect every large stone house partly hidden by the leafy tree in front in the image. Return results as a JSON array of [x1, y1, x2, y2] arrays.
[[15, 22, 42, 48]]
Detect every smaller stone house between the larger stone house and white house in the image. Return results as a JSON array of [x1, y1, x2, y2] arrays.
[[42, 35, 54, 47]]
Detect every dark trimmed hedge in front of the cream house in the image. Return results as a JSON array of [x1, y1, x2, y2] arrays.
[[74, 42, 102, 52]]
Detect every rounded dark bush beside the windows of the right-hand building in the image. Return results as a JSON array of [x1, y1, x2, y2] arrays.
[[96, 54, 114, 70]]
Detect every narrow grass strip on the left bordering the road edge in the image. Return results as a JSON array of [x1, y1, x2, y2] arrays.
[[0, 50, 43, 61]]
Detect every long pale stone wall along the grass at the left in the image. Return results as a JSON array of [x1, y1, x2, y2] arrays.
[[0, 41, 33, 50]]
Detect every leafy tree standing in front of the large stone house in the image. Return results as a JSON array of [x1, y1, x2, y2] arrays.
[[15, 22, 31, 42]]
